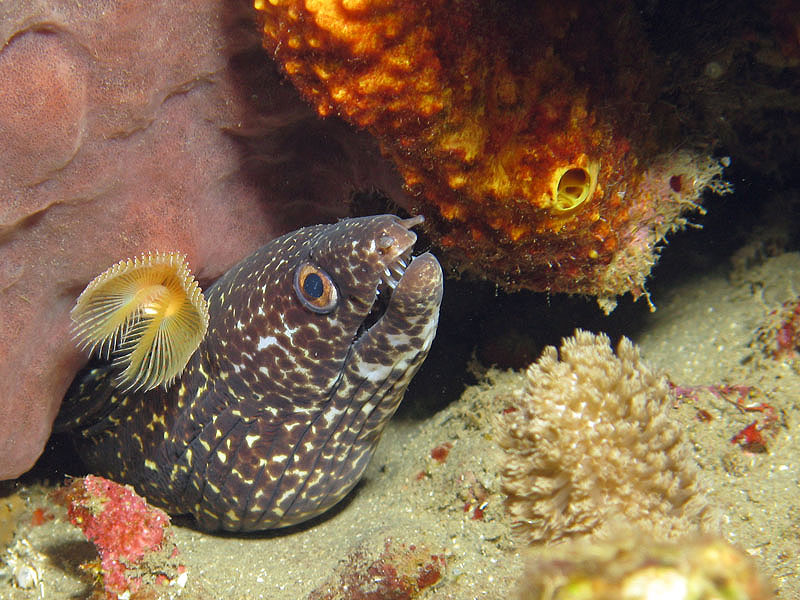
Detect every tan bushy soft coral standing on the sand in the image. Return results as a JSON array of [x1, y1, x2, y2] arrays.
[[498, 330, 711, 543]]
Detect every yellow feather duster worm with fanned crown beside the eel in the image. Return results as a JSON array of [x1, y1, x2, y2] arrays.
[[70, 252, 208, 390]]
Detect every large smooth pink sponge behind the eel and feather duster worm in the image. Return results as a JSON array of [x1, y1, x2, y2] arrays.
[[0, 0, 406, 479]]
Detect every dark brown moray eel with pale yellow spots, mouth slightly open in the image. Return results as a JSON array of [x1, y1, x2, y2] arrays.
[[58, 215, 443, 531]]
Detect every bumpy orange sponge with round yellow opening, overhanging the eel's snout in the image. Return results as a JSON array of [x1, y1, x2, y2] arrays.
[[255, 0, 732, 309]]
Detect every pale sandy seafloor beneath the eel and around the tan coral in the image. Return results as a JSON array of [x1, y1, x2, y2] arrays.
[[0, 188, 800, 600]]
